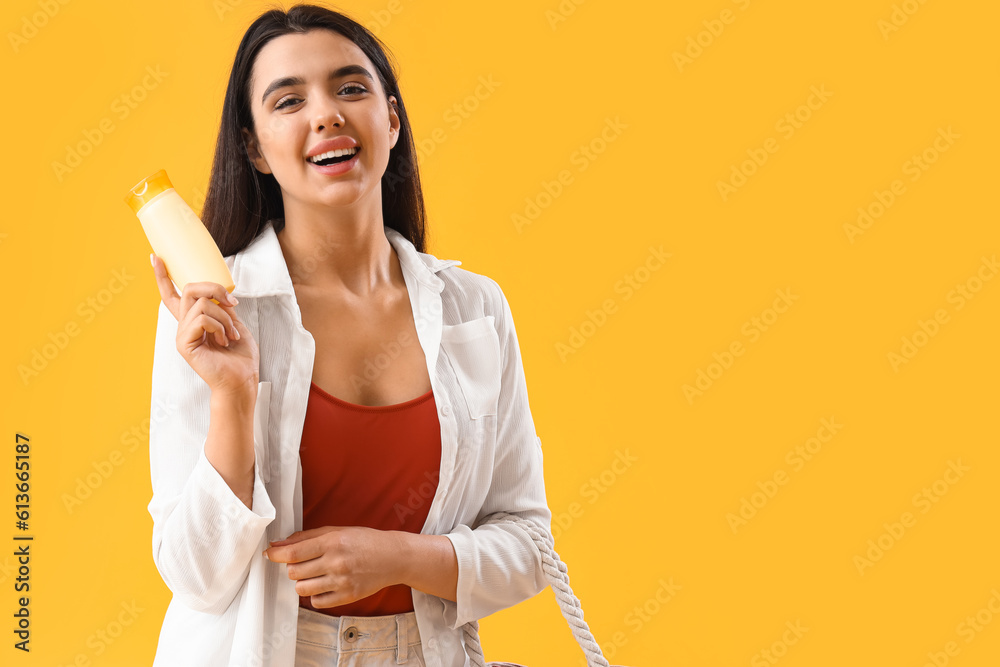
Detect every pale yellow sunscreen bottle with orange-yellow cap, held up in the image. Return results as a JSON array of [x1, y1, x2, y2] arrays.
[[125, 169, 236, 303]]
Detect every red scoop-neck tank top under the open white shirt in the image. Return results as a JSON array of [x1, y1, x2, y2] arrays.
[[299, 383, 441, 616]]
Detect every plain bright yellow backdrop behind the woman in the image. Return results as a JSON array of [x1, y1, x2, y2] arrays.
[[0, 0, 1000, 667]]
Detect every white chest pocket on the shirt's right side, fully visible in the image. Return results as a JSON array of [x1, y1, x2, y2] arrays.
[[441, 315, 501, 419]]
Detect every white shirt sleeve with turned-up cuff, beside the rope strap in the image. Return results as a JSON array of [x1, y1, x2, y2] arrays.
[[445, 279, 553, 629]]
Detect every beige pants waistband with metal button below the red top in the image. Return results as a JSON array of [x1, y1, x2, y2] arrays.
[[297, 607, 420, 664]]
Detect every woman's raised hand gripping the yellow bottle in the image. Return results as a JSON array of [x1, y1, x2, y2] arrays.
[[152, 253, 260, 396]]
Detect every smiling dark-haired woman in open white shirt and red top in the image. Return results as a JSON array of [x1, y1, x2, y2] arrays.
[[149, 5, 552, 667]]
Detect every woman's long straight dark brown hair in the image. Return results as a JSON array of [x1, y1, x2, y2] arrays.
[[201, 4, 427, 257]]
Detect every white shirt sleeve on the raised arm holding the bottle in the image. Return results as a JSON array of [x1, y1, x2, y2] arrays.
[[148, 300, 275, 614]]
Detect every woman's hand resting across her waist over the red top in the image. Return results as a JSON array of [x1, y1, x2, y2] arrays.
[[264, 526, 402, 608]]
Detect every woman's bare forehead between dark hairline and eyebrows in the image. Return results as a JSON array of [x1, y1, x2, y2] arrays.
[[250, 29, 377, 96]]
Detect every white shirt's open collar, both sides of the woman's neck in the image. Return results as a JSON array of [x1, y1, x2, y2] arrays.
[[225, 220, 462, 298]]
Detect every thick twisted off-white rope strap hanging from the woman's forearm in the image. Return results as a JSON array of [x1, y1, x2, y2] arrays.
[[462, 512, 609, 667]]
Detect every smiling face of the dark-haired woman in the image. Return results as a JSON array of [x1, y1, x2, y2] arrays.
[[243, 30, 400, 216]]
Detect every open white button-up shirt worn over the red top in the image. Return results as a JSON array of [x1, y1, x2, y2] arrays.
[[148, 221, 552, 667]]
